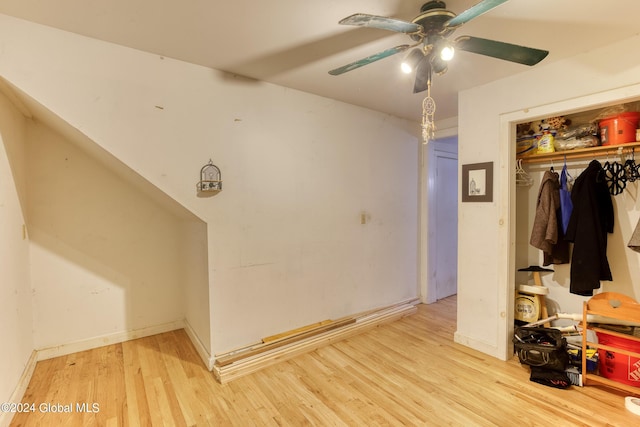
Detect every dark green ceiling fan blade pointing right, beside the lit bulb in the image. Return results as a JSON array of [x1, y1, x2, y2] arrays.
[[455, 36, 549, 65]]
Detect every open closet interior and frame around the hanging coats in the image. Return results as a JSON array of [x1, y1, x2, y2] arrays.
[[501, 92, 640, 360]]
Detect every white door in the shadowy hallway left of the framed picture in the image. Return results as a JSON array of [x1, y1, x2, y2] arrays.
[[430, 142, 458, 300]]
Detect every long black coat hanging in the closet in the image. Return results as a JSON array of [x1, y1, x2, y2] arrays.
[[566, 160, 614, 296]]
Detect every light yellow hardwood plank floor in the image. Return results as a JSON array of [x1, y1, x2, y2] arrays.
[[11, 297, 640, 427]]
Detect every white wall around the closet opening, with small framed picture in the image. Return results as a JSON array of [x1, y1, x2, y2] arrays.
[[455, 37, 640, 358]]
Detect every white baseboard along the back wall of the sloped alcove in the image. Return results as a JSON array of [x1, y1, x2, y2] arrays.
[[37, 319, 185, 361]]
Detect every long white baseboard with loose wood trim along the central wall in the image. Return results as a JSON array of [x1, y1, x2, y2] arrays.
[[213, 299, 418, 384]]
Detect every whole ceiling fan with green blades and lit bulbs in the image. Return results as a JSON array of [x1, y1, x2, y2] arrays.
[[329, 0, 549, 93]]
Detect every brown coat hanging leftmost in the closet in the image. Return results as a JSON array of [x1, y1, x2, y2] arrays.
[[529, 171, 569, 266]]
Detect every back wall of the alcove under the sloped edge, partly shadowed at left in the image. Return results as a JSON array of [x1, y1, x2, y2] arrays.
[[26, 122, 190, 349]]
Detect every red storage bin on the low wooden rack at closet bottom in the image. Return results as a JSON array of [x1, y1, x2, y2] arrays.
[[597, 332, 640, 387]]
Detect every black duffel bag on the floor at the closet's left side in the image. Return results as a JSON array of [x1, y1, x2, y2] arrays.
[[513, 326, 569, 371]]
